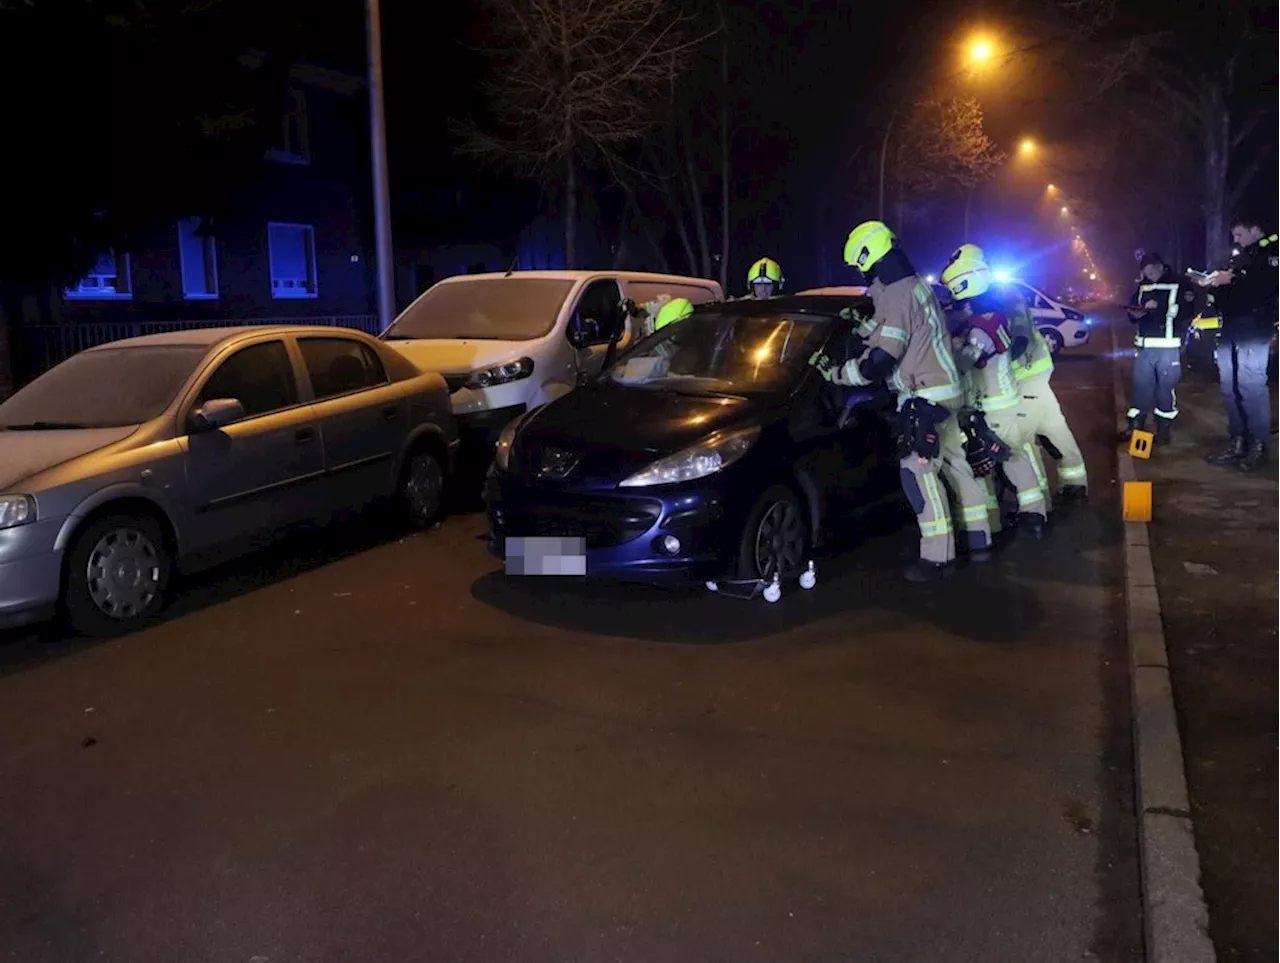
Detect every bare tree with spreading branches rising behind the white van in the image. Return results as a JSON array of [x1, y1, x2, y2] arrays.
[[458, 0, 699, 268]]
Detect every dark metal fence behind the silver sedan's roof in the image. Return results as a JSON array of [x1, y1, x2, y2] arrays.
[[9, 314, 381, 384]]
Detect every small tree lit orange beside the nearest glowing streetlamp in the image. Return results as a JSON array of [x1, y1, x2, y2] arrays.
[[895, 97, 1005, 239]]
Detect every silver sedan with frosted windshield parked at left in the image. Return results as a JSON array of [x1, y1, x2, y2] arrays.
[[0, 327, 457, 635]]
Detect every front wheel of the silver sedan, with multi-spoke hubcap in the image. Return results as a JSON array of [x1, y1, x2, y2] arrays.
[[63, 514, 173, 638]]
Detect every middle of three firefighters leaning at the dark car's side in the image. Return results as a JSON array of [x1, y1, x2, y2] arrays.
[[942, 252, 1047, 538]]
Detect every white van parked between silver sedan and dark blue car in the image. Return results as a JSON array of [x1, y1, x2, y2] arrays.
[[381, 271, 724, 444]]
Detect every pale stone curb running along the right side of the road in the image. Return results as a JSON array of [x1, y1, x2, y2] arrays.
[[1108, 323, 1217, 963]]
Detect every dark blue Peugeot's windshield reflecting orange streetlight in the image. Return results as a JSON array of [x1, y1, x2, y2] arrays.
[[605, 311, 831, 396]]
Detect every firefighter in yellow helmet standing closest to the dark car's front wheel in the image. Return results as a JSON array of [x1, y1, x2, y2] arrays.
[[833, 220, 991, 581]]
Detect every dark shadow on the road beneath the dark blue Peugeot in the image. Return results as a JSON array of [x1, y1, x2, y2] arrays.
[[471, 512, 1042, 645]]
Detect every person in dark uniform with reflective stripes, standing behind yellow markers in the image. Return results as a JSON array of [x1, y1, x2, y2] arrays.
[[1120, 251, 1196, 444]]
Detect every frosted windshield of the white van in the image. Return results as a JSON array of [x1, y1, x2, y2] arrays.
[[383, 278, 573, 341]]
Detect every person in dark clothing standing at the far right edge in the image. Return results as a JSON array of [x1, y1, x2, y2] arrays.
[[1204, 216, 1280, 471]]
